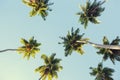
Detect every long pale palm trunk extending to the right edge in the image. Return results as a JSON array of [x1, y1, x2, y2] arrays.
[[77, 41, 120, 50]]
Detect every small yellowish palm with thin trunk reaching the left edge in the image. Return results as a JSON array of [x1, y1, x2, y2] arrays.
[[0, 37, 41, 59]]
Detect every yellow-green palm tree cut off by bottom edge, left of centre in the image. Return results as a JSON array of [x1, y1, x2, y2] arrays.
[[35, 53, 63, 80]]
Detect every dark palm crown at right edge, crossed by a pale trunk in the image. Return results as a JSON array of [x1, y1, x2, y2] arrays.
[[97, 36, 120, 64]]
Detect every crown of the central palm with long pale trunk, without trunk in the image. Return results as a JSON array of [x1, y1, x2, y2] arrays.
[[60, 28, 88, 56]]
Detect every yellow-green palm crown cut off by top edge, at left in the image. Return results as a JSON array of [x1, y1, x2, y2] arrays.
[[23, 0, 53, 20]]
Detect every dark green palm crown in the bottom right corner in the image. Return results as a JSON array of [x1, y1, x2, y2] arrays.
[[90, 63, 114, 80]]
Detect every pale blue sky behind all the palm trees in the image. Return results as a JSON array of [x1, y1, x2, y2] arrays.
[[0, 0, 120, 80]]
